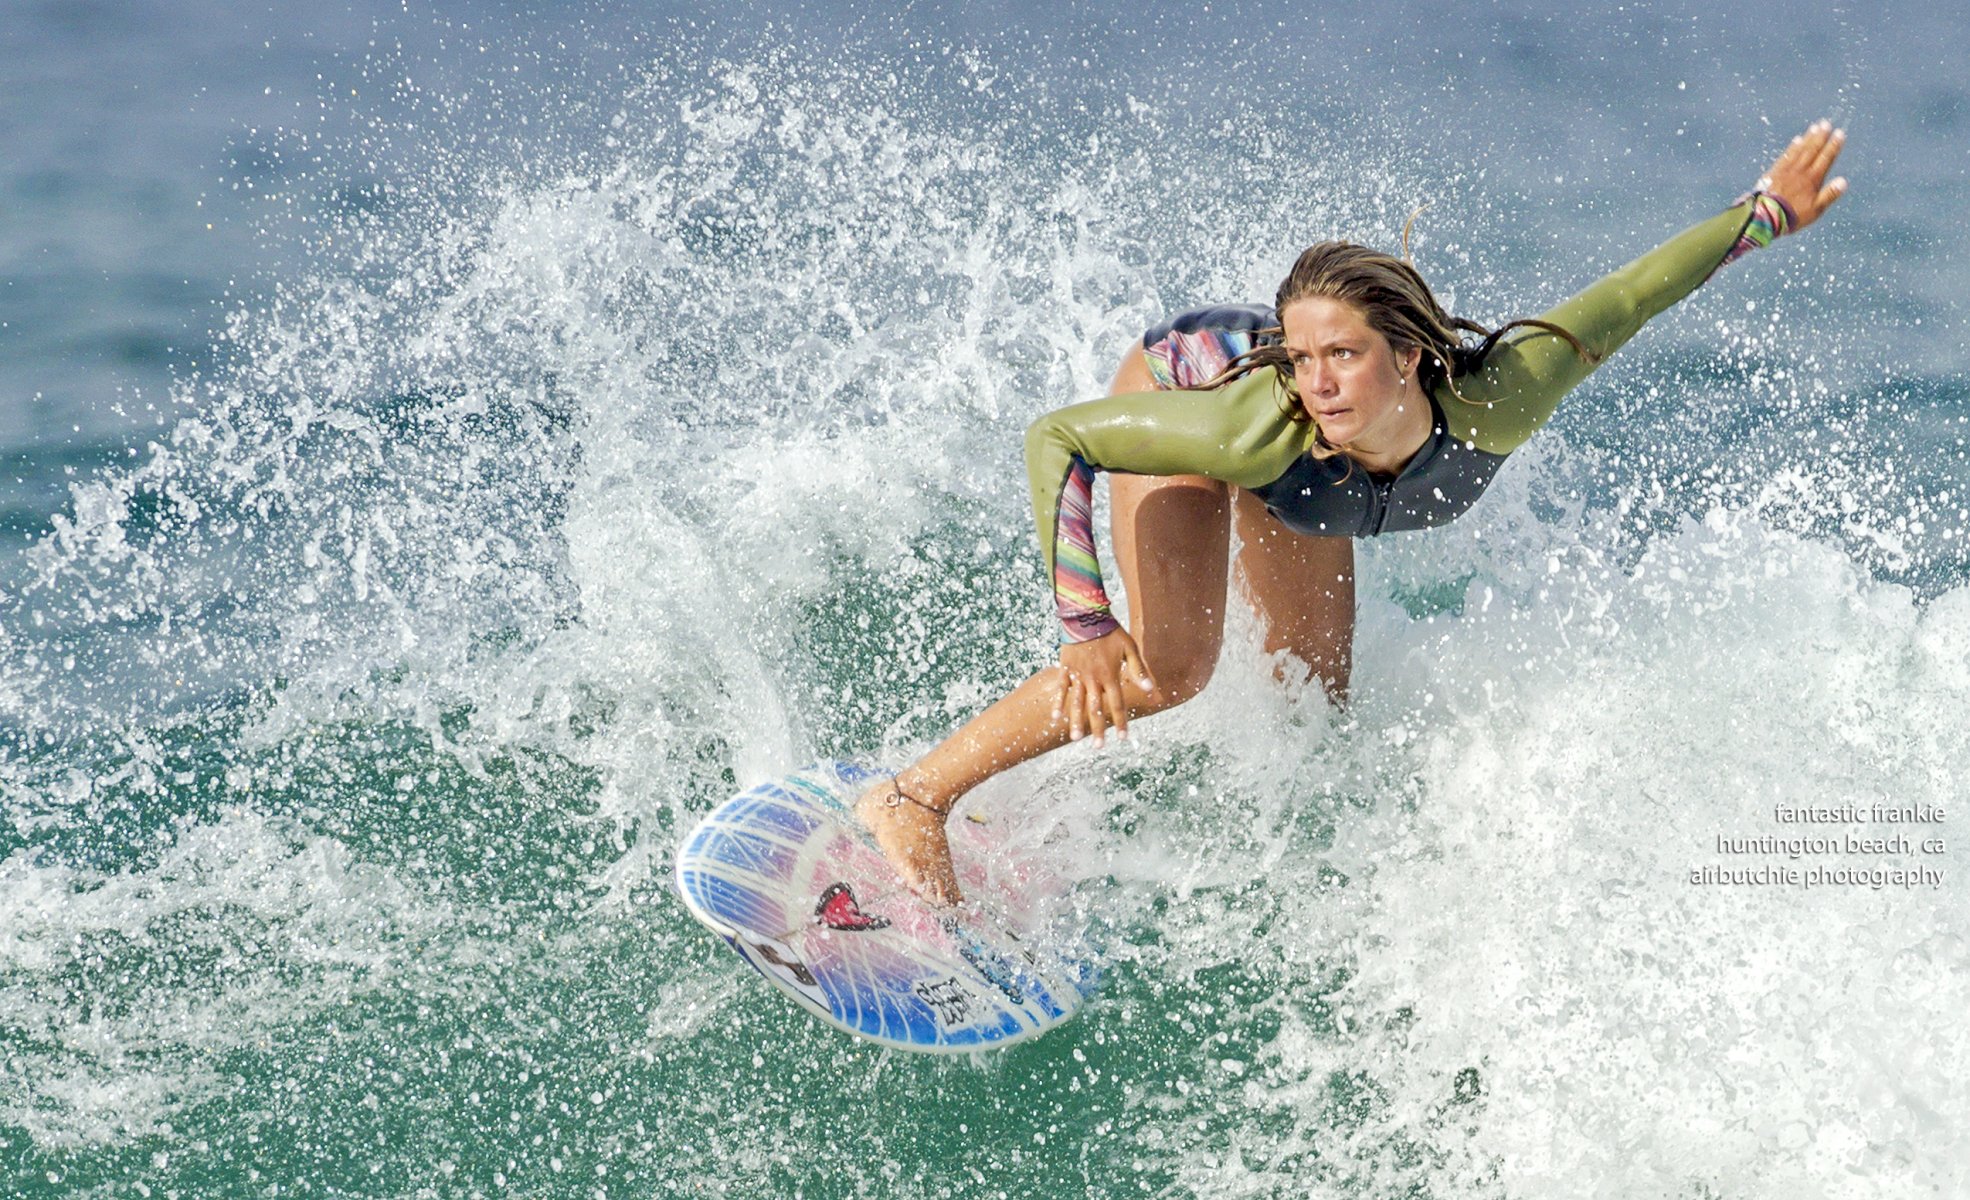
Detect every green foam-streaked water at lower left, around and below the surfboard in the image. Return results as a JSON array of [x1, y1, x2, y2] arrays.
[[0, 697, 1481, 1196]]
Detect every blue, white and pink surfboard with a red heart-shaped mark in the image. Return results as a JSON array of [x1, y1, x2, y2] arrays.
[[676, 763, 1095, 1052]]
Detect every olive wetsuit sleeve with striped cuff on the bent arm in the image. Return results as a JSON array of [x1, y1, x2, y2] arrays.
[[1026, 368, 1314, 642]]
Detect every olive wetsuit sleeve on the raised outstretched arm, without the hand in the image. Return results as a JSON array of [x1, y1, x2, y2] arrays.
[[1438, 195, 1783, 453]]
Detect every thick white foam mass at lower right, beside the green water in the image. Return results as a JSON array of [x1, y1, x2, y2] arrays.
[[1071, 482, 1970, 1198]]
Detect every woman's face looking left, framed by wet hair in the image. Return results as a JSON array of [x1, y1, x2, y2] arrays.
[[1279, 296, 1430, 461]]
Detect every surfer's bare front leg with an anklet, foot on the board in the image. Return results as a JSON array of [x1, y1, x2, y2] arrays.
[[855, 351, 1231, 902]]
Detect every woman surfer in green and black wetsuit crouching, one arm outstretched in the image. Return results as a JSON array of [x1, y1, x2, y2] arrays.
[[857, 120, 1846, 902]]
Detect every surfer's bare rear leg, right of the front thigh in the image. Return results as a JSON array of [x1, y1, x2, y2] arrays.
[[1231, 489, 1353, 703]]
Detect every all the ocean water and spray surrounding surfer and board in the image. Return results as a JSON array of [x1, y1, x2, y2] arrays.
[[0, 0, 1970, 1200]]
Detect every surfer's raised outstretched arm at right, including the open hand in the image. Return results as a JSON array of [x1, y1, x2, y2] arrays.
[[1444, 120, 1846, 453]]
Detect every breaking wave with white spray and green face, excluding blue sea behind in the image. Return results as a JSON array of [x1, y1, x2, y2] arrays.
[[0, 21, 1970, 1198]]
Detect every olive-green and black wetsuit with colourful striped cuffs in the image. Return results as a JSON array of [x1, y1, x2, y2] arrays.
[[1026, 193, 1793, 642]]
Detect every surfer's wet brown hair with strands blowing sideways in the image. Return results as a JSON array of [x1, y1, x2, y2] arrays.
[[1198, 231, 1600, 449]]
